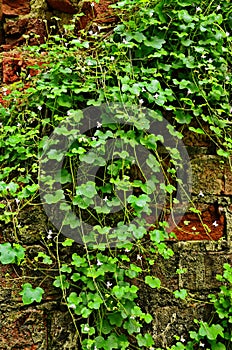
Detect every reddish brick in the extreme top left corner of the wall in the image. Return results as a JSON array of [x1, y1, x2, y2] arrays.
[[2, 0, 30, 16]]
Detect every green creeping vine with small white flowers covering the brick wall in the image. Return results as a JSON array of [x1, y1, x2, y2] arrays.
[[0, 0, 232, 350]]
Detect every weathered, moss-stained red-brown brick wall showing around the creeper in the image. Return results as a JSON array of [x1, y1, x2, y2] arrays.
[[0, 0, 232, 350]]
